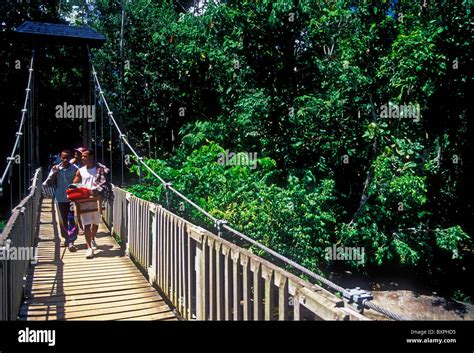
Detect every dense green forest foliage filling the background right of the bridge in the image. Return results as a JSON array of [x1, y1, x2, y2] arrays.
[[87, 0, 474, 280]]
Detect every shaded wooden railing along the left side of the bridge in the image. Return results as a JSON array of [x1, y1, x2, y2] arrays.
[[0, 168, 42, 320]]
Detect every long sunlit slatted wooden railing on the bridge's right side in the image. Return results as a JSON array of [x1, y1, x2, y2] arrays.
[[104, 187, 366, 320]]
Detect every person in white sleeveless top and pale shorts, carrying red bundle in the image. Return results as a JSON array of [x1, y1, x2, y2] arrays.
[[74, 149, 111, 259]]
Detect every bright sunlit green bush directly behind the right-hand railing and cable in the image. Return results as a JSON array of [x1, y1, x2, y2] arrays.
[[129, 142, 336, 271]]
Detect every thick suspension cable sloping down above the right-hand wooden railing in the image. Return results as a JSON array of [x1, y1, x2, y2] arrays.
[[89, 52, 406, 321]]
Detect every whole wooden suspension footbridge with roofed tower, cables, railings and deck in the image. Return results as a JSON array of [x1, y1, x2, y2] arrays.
[[0, 22, 400, 321]]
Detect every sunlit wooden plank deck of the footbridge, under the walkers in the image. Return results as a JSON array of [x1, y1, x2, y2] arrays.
[[20, 199, 177, 321]]
